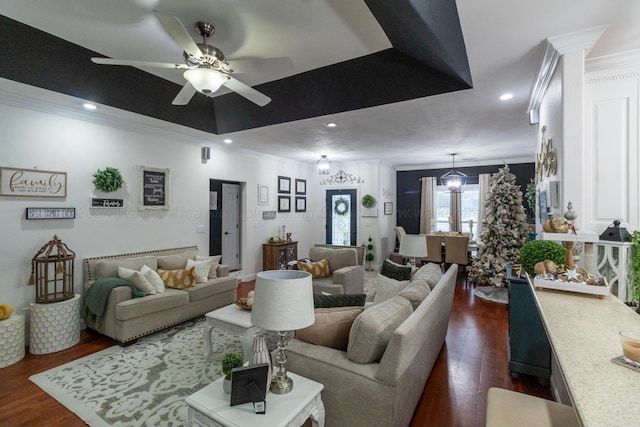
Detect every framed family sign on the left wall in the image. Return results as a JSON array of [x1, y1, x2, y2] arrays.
[[0, 166, 67, 198]]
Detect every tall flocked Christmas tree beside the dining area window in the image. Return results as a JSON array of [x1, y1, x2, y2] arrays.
[[467, 165, 527, 286]]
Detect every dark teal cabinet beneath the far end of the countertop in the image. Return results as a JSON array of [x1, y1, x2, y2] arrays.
[[507, 267, 551, 386]]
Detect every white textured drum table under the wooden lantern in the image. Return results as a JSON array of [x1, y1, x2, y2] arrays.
[[29, 294, 80, 354]]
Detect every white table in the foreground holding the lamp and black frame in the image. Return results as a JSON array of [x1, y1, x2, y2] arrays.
[[185, 372, 324, 427]]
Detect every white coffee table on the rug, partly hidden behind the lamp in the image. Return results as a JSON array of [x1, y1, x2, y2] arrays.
[[204, 304, 261, 359]]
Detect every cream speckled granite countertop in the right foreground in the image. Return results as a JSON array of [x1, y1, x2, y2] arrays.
[[533, 289, 640, 426]]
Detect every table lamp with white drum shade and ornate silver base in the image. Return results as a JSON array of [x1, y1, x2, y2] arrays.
[[251, 270, 315, 394]]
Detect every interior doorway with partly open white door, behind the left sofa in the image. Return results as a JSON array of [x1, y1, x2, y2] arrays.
[[209, 179, 242, 271]]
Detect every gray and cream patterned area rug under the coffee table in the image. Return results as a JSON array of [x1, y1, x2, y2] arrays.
[[30, 317, 242, 427]]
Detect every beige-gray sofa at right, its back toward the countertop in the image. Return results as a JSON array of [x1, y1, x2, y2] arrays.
[[287, 264, 458, 427]]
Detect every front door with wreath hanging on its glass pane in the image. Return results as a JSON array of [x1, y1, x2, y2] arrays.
[[325, 189, 358, 246]]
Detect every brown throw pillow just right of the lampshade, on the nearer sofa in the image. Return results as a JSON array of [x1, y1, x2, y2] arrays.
[[296, 307, 363, 351]]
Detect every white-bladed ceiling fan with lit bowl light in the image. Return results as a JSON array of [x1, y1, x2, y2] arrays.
[[91, 11, 282, 107]]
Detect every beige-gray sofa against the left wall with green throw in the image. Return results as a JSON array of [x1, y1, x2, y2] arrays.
[[83, 246, 238, 344]]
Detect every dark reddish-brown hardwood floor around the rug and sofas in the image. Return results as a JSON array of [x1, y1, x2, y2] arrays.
[[0, 281, 551, 427]]
